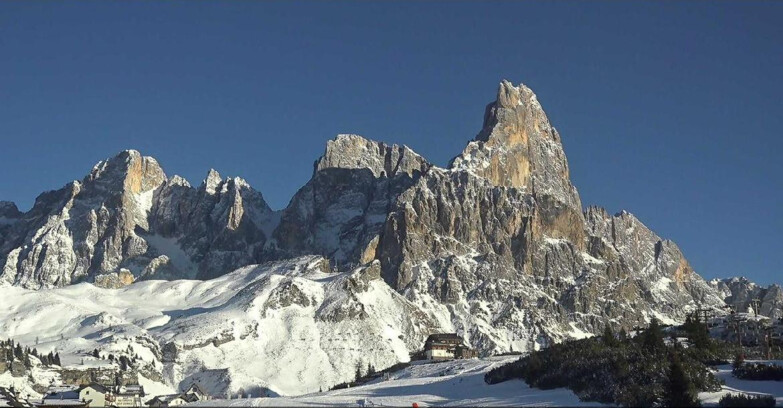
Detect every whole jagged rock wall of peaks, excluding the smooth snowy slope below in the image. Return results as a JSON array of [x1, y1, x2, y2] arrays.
[[0, 81, 748, 352]]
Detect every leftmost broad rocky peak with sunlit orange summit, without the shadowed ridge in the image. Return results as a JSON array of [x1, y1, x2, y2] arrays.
[[0, 150, 166, 288]]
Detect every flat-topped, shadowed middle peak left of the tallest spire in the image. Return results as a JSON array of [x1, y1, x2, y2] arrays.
[[267, 135, 431, 267]]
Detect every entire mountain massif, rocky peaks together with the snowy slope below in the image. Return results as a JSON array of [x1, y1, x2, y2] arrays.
[[0, 81, 772, 394]]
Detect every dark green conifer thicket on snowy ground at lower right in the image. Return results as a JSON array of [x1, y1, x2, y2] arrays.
[[485, 319, 720, 407]]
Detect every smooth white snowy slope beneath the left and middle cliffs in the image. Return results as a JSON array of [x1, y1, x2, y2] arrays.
[[0, 257, 431, 395]]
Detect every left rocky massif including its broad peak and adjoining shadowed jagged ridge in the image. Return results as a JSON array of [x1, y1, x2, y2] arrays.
[[0, 150, 271, 288]]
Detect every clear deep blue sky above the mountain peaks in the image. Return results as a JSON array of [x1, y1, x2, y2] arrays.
[[0, 1, 783, 283]]
